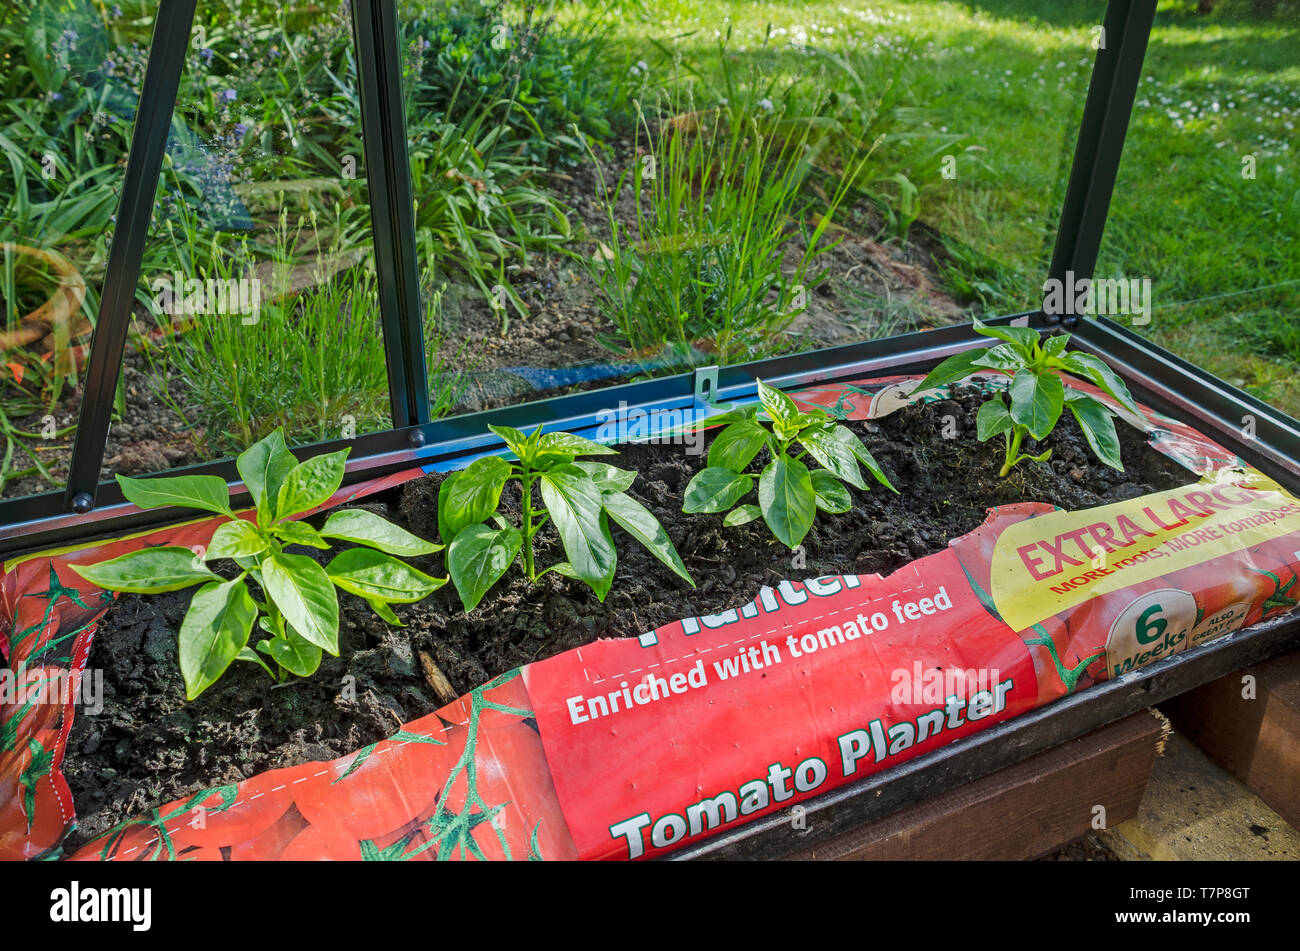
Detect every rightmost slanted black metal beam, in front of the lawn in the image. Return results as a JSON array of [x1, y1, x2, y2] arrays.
[[1047, 0, 1156, 329]]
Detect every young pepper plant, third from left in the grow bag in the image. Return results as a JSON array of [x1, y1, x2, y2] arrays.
[[681, 381, 898, 550]]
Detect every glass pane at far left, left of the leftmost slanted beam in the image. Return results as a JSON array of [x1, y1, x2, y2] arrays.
[[0, 0, 118, 498]]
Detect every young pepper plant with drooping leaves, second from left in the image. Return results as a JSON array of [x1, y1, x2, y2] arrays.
[[438, 426, 696, 611]]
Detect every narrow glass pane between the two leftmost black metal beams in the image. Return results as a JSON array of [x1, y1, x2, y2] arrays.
[[103, 0, 391, 478]]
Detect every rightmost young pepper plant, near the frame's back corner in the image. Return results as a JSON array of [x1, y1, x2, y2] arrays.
[[915, 320, 1143, 477]]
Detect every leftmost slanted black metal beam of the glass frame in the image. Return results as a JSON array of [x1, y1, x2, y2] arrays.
[[62, 0, 196, 512]]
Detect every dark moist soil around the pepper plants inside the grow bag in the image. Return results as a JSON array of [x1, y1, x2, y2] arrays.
[[64, 388, 1195, 851]]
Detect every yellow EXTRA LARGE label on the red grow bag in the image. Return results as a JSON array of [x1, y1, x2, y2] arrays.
[[992, 469, 1300, 630]]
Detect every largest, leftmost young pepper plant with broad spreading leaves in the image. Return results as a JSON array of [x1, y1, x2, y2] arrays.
[[73, 430, 447, 700]]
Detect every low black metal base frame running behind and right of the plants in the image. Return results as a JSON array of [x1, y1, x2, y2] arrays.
[[0, 314, 1300, 557]]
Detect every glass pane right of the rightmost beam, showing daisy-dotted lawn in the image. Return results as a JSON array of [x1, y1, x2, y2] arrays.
[[1097, 0, 1300, 415]]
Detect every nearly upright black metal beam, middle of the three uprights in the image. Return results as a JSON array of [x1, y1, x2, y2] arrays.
[[351, 0, 429, 427]]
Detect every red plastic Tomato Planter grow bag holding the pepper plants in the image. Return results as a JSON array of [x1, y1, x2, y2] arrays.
[[0, 377, 1300, 860]]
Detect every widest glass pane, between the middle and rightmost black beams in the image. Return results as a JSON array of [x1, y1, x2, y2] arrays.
[[400, 0, 1105, 412]]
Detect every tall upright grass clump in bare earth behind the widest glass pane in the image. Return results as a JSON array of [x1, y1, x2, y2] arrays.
[[584, 38, 870, 366]]
